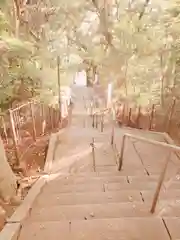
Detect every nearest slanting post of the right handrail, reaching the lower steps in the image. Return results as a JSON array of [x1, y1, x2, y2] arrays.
[[150, 151, 171, 213]]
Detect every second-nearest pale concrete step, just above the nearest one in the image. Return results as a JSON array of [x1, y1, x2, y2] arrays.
[[29, 202, 153, 222]]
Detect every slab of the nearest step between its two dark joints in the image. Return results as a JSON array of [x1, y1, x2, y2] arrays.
[[64, 218, 169, 240]]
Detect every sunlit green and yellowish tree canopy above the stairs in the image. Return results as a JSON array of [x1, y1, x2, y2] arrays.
[[0, 0, 180, 109]]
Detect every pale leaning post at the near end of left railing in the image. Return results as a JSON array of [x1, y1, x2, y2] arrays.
[[9, 110, 20, 166]]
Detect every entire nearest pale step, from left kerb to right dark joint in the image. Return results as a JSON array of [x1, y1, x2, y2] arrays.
[[19, 218, 169, 240]]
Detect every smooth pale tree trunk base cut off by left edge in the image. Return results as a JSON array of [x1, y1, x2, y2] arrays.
[[0, 137, 17, 202]]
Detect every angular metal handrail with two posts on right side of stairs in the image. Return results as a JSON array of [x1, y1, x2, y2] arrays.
[[118, 133, 180, 213]]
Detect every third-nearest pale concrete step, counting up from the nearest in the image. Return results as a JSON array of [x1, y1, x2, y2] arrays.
[[35, 190, 142, 207]]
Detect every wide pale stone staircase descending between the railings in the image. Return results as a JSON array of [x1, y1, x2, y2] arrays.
[[11, 87, 180, 240]]
